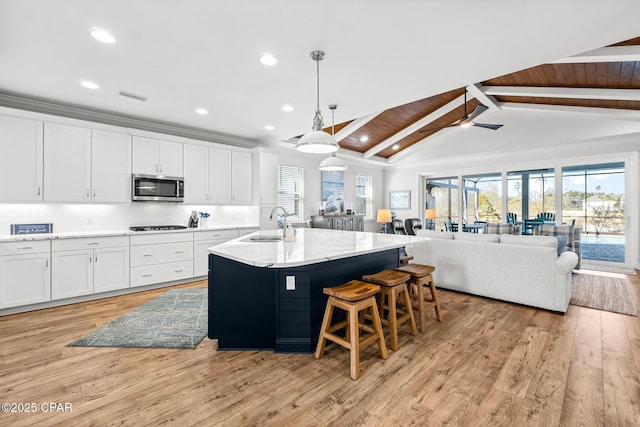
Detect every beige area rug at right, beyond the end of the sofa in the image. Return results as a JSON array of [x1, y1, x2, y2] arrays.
[[569, 274, 638, 316]]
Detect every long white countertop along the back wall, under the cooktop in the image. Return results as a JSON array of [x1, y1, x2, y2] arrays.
[[0, 225, 258, 243]]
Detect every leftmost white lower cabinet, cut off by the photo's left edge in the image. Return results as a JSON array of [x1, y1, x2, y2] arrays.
[[0, 240, 51, 308]]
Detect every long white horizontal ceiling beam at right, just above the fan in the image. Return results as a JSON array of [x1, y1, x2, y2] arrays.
[[482, 86, 640, 101]]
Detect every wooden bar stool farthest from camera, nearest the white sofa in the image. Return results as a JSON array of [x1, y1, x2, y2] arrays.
[[396, 264, 442, 333]]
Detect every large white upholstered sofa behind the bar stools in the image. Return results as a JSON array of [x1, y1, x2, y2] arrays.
[[407, 230, 578, 313]]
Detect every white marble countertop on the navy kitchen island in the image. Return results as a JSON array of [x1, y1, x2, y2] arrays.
[[209, 228, 428, 268]]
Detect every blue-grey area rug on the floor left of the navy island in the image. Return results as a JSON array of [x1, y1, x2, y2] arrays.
[[68, 289, 208, 348]]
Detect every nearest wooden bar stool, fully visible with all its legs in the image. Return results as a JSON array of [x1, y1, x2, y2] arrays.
[[315, 280, 389, 380]]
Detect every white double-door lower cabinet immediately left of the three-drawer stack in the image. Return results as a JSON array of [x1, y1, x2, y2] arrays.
[[51, 236, 129, 300]]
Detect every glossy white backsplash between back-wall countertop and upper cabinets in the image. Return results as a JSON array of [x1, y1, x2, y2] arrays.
[[0, 202, 259, 235]]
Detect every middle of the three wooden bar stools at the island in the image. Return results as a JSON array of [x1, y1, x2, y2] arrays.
[[362, 270, 418, 350]]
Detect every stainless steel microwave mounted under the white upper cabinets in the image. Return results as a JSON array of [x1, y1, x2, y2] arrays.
[[131, 173, 184, 202]]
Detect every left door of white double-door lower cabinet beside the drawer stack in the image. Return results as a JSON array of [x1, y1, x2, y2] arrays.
[[51, 249, 93, 300]]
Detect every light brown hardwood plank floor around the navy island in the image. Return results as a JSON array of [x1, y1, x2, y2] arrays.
[[0, 276, 640, 426]]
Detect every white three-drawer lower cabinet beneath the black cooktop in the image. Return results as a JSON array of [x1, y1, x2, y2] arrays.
[[131, 232, 193, 287]]
